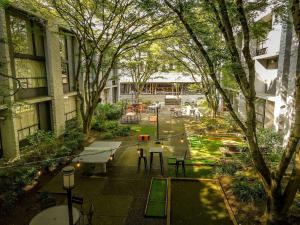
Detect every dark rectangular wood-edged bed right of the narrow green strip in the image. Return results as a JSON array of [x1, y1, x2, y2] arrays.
[[168, 179, 236, 225]]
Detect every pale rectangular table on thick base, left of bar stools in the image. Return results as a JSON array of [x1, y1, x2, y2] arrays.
[[73, 141, 122, 173]]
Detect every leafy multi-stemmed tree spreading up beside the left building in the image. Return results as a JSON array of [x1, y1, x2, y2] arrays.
[[40, 0, 172, 134]]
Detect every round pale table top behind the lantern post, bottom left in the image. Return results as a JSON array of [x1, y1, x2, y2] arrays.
[[29, 205, 80, 225]]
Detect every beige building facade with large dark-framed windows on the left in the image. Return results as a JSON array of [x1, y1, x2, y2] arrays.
[[0, 6, 117, 159]]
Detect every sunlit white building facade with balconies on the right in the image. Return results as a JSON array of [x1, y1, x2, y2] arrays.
[[228, 9, 298, 144]]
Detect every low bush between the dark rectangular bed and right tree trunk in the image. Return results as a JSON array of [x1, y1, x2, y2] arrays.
[[232, 177, 266, 202]]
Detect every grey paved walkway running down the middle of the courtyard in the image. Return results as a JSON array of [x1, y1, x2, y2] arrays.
[[41, 107, 188, 225]]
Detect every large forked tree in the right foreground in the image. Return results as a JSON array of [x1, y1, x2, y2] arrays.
[[143, 0, 300, 225]]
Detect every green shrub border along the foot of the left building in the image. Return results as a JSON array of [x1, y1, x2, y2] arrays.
[[0, 120, 84, 216]]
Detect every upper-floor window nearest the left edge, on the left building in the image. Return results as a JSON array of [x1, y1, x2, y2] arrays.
[[7, 11, 47, 88]]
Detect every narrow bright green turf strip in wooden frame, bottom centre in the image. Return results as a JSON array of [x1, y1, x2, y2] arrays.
[[145, 178, 167, 217]]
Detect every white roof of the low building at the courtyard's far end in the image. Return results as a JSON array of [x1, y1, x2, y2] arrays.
[[120, 72, 200, 83]]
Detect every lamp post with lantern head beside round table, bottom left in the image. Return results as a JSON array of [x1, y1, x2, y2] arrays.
[[62, 166, 75, 225]]
